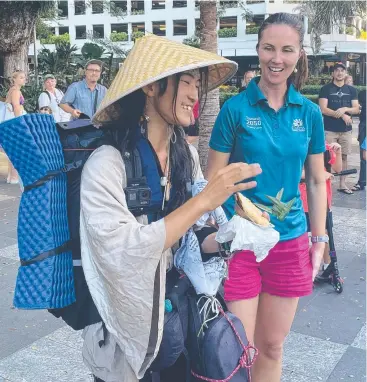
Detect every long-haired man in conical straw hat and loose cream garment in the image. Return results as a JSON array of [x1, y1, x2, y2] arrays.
[[80, 35, 261, 382]]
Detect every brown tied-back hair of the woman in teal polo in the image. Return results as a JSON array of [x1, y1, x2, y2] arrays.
[[256, 13, 308, 90]]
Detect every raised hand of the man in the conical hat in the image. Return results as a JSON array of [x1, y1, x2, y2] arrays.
[[197, 163, 262, 211]]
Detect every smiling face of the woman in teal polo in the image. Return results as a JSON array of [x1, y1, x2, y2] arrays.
[[257, 24, 303, 86]]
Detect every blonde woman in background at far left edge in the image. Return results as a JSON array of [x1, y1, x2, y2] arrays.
[[5, 70, 27, 184]]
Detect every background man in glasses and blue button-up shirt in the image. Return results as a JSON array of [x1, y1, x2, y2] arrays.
[[59, 60, 107, 119]]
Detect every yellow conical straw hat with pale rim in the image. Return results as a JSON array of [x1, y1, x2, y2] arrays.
[[93, 34, 238, 123]]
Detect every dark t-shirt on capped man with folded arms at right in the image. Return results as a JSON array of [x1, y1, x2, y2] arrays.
[[319, 82, 357, 133]]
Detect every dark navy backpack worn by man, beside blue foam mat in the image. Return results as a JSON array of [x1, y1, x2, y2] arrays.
[[47, 120, 178, 330]]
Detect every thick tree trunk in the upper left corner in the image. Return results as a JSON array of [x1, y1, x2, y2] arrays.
[[0, 1, 56, 77]]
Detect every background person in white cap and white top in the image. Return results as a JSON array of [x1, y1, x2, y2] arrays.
[[38, 74, 71, 122]]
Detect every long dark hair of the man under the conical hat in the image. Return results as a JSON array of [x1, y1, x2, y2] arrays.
[[109, 68, 208, 213]]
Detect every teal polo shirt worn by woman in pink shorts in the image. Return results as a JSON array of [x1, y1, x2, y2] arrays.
[[209, 77, 325, 241]]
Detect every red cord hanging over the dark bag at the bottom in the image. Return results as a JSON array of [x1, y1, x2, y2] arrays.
[[191, 308, 258, 382]]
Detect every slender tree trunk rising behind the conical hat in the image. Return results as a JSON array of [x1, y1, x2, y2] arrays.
[[199, 0, 219, 172]]
